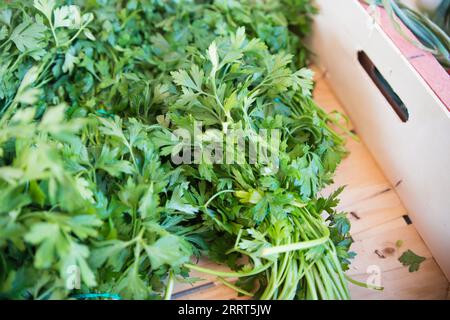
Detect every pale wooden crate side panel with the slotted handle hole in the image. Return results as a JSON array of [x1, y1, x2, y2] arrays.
[[311, 0, 450, 279]]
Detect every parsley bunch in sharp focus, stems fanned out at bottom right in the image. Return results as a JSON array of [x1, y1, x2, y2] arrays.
[[164, 28, 356, 299]]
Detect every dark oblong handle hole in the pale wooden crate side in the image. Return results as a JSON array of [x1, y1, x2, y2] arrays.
[[358, 51, 409, 122]]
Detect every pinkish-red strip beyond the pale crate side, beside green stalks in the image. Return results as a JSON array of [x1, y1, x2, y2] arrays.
[[361, 3, 450, 111]]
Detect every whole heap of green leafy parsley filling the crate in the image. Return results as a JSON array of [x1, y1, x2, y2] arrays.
[[0, 0, 352, 299]]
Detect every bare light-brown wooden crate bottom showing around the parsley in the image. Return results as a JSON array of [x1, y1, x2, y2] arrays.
[[174, 68, 449, 299]]
